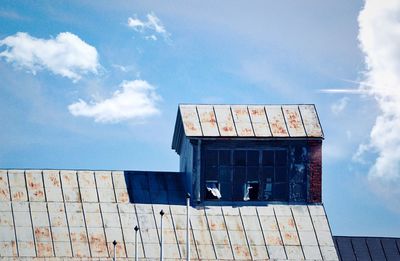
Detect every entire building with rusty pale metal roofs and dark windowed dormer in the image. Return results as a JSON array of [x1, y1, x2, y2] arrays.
[[0, 105, 396, 260]]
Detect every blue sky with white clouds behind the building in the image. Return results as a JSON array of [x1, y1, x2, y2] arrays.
[[0, 0, 400, 237]]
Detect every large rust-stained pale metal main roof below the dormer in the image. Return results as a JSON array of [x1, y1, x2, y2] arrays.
[[0, 170, 338, 260]]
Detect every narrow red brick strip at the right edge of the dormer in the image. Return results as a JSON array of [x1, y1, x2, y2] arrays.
[[308, 141, 322, 203]]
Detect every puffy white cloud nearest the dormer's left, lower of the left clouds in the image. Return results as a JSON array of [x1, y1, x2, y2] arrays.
[[68, 80, 161, 123]]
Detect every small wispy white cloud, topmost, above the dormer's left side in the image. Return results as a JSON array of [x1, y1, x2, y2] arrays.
[[128, 13, 170, 41]]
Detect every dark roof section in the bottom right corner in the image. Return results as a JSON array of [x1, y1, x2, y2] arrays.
[[334, 236, 400, 261]]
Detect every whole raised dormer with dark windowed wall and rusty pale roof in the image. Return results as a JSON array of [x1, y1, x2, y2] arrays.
[[172, 104, 324, 204]]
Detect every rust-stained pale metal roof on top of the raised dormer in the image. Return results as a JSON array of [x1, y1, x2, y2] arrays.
[[172, 104, 324, 149]]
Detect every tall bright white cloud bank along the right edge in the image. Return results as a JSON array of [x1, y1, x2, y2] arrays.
[[357, 0, 400, 206]]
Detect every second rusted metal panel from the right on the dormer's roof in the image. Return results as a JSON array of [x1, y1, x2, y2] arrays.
[[282, 105, 306, 137]]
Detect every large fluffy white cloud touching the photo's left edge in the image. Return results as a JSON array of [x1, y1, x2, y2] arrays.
[[0, 32, 100, 81]]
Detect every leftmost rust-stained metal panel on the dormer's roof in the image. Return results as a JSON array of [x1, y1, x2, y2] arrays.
[[179, 105, 202, 137]]
